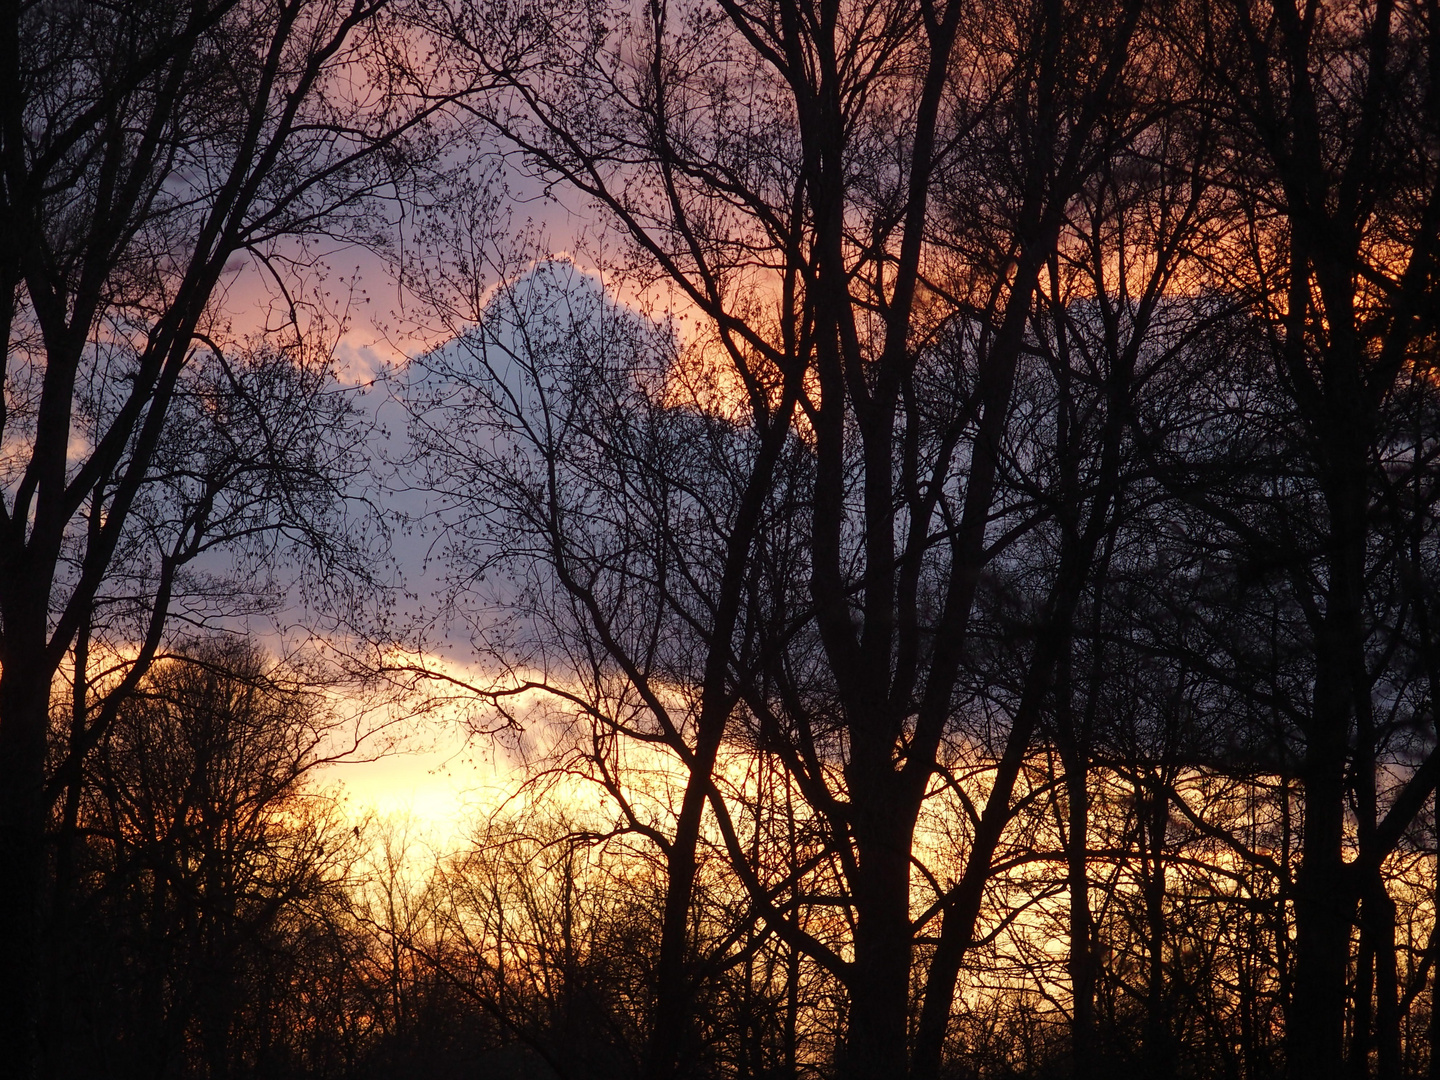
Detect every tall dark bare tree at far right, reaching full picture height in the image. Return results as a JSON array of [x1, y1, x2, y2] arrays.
[[1152, 3, 1440, 1077]]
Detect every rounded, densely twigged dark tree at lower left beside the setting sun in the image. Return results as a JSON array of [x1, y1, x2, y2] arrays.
[[40, 639, 489, 1079]]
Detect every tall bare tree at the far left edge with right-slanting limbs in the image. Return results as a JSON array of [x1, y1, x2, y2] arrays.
[[0, 0, 443, 1076]]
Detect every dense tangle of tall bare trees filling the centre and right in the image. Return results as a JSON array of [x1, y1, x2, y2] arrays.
[[394, 0, 1440, 1079]]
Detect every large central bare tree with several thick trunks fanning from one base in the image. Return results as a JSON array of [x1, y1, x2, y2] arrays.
[[411, 0, 1198, 1076]]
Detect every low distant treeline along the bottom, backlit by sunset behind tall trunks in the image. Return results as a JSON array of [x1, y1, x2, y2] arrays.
[[45, 641, 1436, 1079]]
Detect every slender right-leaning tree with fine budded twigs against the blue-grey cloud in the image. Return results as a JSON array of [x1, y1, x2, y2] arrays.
[[412, 247, 798, 1076]]
